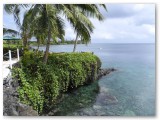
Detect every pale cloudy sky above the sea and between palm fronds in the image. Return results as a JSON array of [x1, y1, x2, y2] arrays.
[[3, 3, 155, 43]]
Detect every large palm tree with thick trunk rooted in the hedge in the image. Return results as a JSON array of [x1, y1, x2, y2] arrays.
[[32, 4, 65, 63]]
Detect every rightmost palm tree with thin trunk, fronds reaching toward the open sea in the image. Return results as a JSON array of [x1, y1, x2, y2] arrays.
[[55, 4, 107, 52]]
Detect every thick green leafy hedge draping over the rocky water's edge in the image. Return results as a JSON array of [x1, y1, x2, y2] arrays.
[[13, 52, 101, 113]]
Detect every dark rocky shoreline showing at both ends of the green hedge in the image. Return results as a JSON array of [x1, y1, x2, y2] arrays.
[[3, 68, 116, 116]]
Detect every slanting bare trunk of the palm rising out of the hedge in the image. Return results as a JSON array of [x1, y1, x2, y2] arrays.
[[43, 28, 51, 64]]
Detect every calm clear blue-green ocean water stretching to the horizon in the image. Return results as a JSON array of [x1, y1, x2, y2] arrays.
[[32, 43, 156, 116]]
